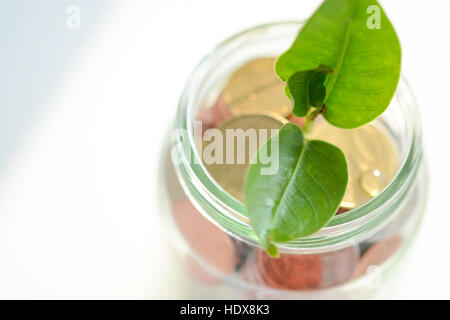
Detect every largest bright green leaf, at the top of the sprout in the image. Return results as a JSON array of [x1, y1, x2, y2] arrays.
[[275, 0, 401, 128]]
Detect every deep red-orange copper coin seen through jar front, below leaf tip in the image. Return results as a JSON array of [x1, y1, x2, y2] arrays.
[[258, 249, 323, 290]]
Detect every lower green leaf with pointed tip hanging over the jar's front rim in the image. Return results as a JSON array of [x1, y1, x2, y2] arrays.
[[245, 123, 348, 256]]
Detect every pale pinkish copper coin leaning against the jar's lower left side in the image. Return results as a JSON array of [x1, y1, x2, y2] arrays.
[[173, 199, 238, 275]]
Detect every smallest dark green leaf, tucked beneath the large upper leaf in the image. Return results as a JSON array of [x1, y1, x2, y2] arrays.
[[286, 65, 332, 117]]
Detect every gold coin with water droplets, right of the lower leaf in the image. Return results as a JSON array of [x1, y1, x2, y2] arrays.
[[308, 119, 398, 209]]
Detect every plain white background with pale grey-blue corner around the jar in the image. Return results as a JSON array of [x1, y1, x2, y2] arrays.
[[0, 0, 450, 298]]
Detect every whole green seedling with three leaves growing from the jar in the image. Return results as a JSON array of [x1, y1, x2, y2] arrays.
[[245, 0, 401, 257]]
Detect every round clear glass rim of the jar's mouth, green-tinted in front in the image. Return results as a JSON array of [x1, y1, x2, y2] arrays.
[[175, 21, 422, 252]]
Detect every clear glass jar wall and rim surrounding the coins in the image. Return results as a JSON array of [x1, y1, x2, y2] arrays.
[[160, 22, 427, 299]]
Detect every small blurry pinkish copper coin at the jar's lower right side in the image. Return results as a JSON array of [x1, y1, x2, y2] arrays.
[[353, 235, 403, 279]]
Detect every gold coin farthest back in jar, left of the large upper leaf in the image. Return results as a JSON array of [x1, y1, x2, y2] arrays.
[[223, 58, 292, 117]]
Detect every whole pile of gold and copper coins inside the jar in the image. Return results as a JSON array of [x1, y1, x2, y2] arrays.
[[172, 57, 401, 290]]
